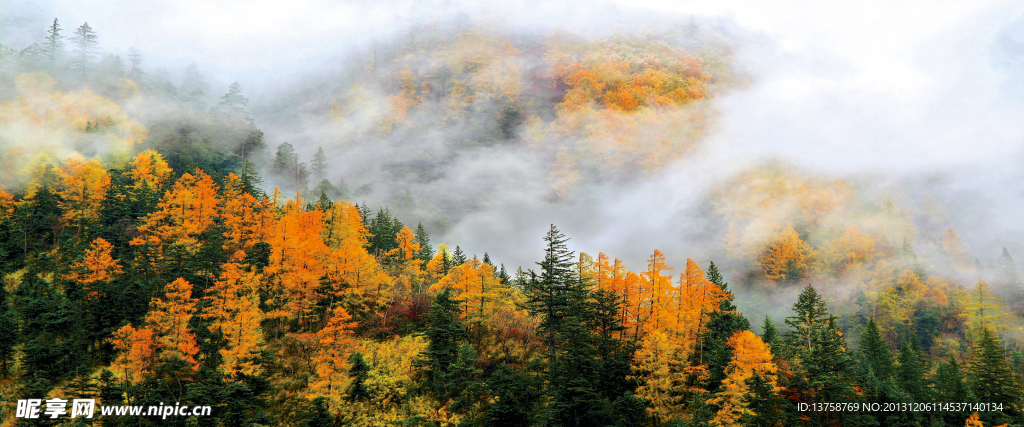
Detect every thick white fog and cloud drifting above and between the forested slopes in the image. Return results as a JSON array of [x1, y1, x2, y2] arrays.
[[0, 0, 1024, 317]]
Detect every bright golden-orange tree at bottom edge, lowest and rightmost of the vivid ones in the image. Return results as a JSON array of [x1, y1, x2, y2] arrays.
[[708, 331, 779, 427]]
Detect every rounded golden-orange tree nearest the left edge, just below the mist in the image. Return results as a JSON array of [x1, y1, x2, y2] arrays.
[[57, 154, 111, 236]]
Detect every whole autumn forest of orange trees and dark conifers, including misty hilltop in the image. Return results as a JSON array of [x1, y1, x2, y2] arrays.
[[0, 14, 1024, 427]]
